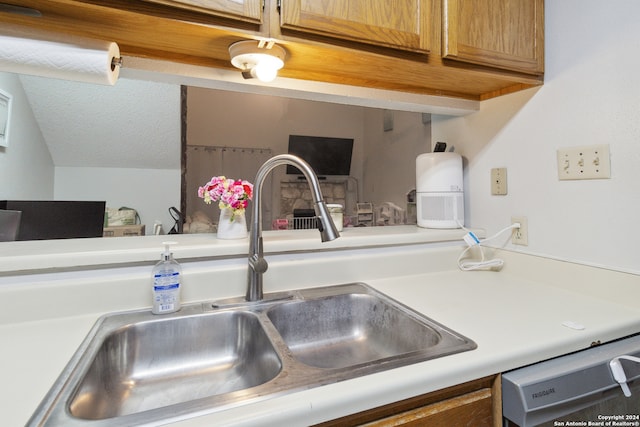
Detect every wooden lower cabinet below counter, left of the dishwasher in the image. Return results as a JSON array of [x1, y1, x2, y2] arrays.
[[318, 375, 502, 427]]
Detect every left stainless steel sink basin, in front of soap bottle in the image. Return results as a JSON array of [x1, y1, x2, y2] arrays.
[[69, 312, 282, 420]]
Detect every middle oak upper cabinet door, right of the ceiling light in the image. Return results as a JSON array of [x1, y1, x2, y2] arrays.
[[280, 0, 429, 52]]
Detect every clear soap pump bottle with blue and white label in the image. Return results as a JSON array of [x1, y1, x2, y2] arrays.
[[151, 242, 182, 314]]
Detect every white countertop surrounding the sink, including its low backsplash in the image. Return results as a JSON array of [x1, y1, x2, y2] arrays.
[[0, 239, 640, 427]]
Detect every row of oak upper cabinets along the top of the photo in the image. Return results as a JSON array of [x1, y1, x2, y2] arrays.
[[0, 0, 544, 101]]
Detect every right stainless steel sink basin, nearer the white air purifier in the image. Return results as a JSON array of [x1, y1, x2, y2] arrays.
[[267, 293, 442, 368]]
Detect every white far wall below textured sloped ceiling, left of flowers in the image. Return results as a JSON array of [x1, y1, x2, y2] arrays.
[[55, 167, 180, 234]]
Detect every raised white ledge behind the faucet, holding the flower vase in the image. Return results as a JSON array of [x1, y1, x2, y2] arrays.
[[0, 225, 472, 273]]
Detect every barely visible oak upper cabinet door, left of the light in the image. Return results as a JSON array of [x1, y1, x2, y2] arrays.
[[143, 0, 262, 24]]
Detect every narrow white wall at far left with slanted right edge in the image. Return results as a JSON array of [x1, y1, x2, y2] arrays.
[[0, 73, 54, 200]]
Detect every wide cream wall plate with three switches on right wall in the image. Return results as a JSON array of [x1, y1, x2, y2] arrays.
[[557, 144, 611, 180]]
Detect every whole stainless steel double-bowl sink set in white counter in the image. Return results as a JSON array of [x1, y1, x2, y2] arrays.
[[28, 283, 476, 426]]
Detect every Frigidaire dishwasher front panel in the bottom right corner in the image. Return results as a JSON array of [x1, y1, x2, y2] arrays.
[[502, 335, 640, 427]]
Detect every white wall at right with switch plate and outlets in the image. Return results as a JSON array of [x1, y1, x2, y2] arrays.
[[432, 0, 640, 273]]
